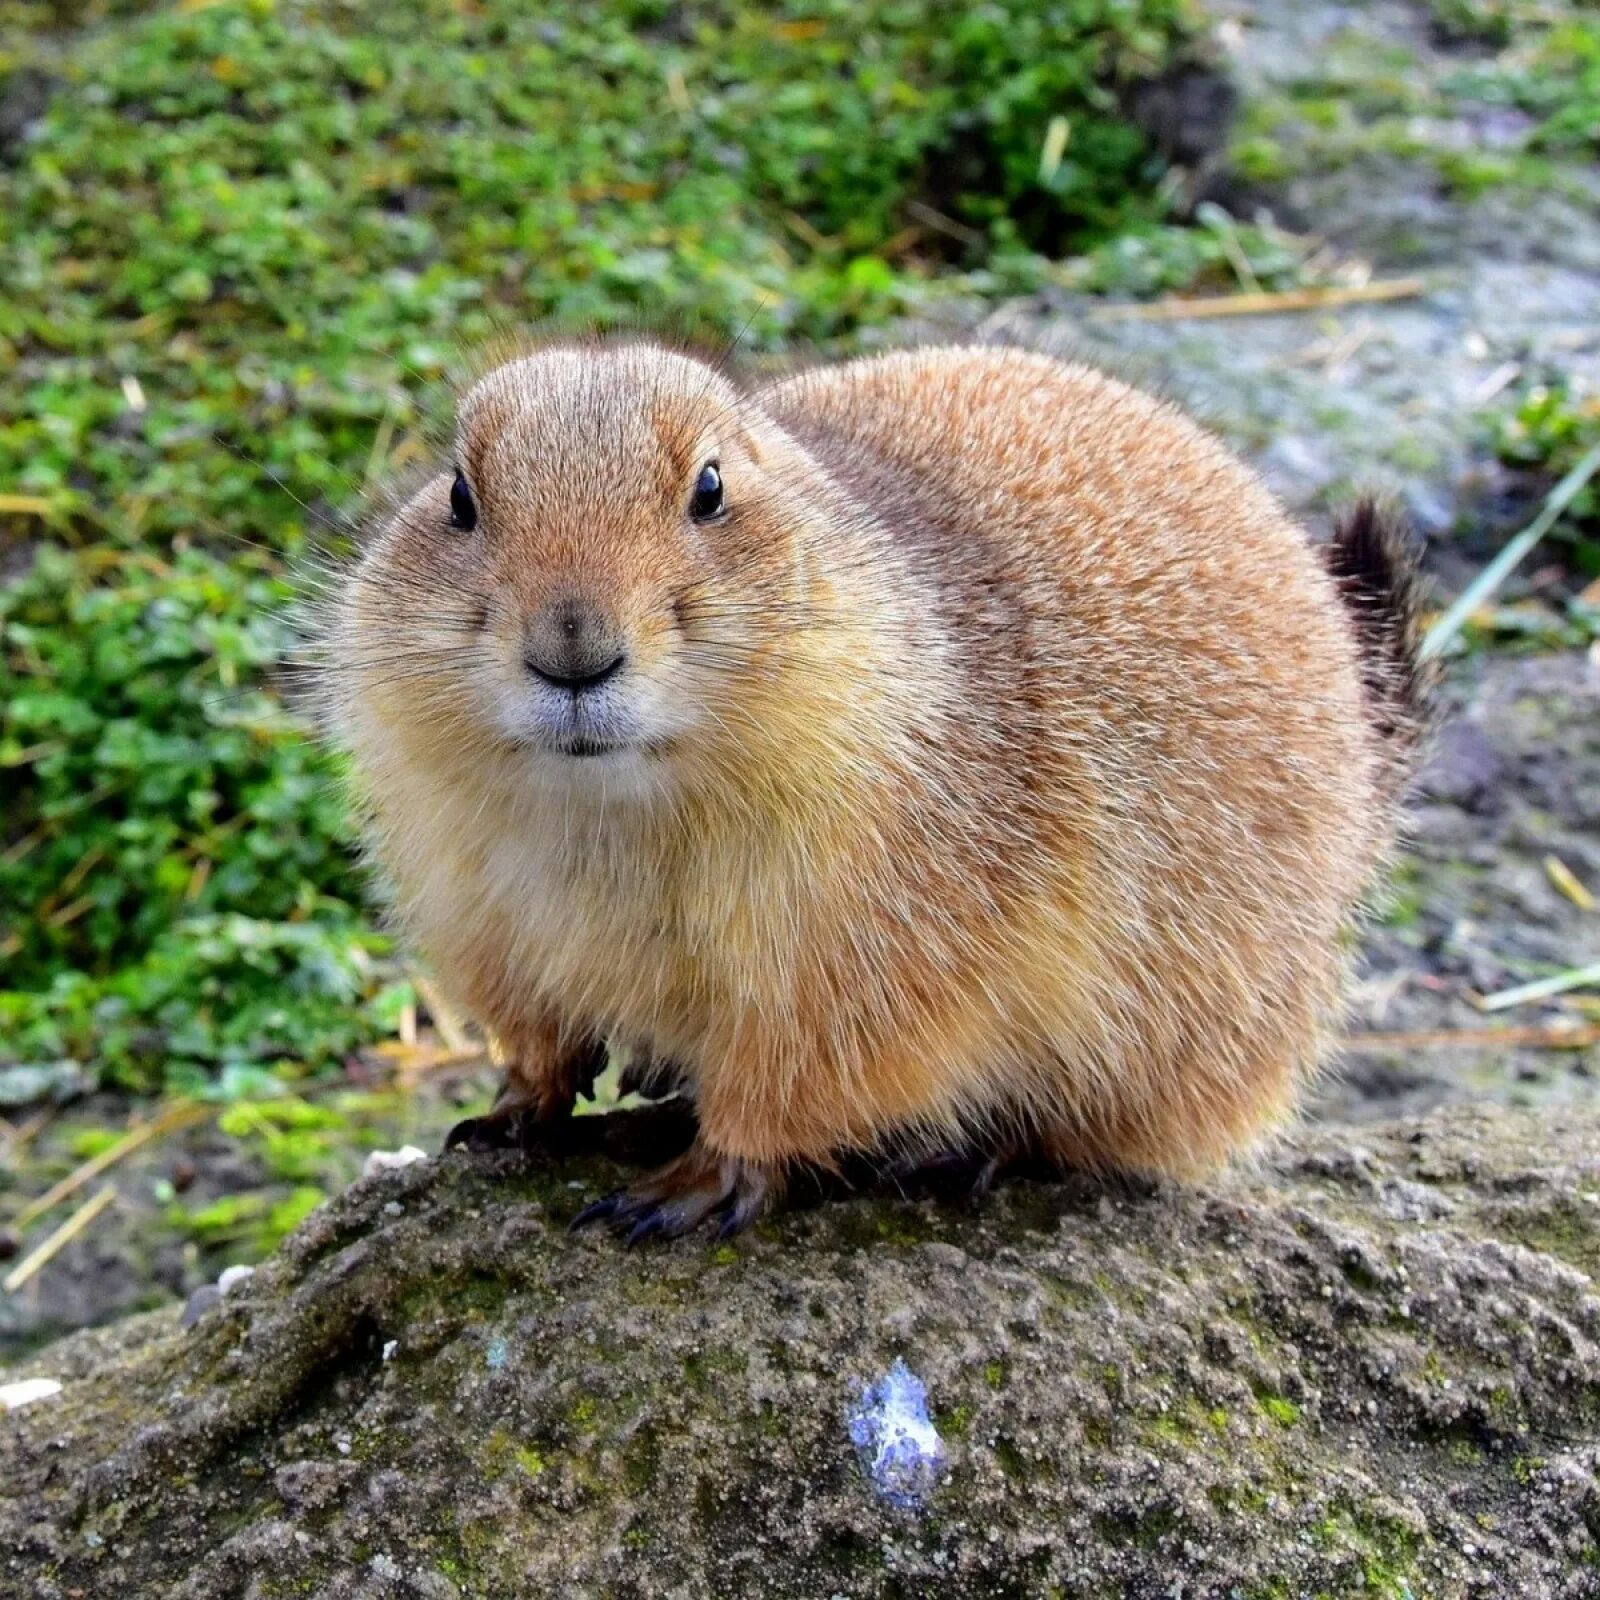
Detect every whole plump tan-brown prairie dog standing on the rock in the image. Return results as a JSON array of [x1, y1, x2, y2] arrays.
[[318, 342, 1416, 1237]]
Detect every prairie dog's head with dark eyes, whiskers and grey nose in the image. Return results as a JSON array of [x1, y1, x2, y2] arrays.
[[331, 344, 827, 795]]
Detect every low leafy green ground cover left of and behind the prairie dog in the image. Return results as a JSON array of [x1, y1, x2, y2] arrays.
[[0, 0, 1203, 1088]]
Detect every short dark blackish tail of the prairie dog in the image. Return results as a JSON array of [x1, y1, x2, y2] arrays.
[[1326, 499, 1430, 787]]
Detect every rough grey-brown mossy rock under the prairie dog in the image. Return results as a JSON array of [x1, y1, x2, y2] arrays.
[[0, 1109, 1600, 1600]]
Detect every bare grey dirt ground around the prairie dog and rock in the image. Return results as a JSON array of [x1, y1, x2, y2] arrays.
[[0, 0, 1600, 1358]]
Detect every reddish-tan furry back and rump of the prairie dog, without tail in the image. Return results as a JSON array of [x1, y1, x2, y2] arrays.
[[765, 349, 1390, 1166]]
